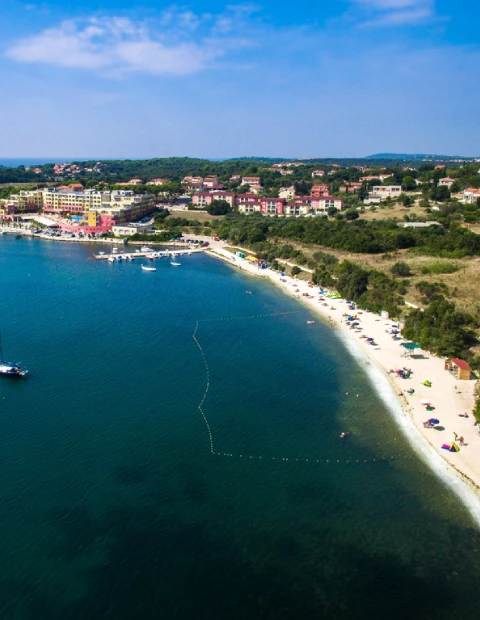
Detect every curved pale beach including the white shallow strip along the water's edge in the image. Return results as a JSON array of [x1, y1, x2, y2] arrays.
[[207, 247, 480, 526]]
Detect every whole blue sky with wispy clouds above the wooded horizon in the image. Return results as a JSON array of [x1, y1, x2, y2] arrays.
[[0, 0, 480, 158]]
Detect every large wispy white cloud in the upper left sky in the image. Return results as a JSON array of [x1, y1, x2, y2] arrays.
[[6, 12, 241, 76]]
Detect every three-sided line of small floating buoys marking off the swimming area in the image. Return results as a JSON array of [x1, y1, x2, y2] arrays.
[[192, 312, 406, 464]]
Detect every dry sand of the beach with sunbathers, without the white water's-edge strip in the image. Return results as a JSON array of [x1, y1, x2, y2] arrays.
[[209, 243, 480, 494]]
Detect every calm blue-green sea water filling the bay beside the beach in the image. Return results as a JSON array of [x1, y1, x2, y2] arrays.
[[0, 236, 480, 620]]
